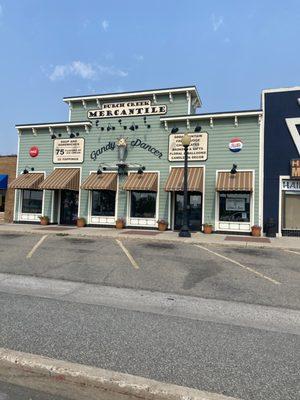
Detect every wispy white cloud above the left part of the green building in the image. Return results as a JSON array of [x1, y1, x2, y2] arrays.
[[49, 61, 128, 81]]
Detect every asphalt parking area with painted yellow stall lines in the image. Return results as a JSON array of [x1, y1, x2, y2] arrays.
[[0, 233, 300, 309]]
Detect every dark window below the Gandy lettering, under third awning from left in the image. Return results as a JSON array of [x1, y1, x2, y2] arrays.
[[92, 190, 116, 217]]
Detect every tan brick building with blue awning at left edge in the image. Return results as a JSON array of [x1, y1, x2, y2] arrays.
[[0, 155, 17, 223]]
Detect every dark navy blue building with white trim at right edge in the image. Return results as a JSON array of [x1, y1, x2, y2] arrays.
[[262, 87, 300, 236]]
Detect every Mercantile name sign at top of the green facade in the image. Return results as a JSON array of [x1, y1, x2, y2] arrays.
[[87, 100, 167, 119]]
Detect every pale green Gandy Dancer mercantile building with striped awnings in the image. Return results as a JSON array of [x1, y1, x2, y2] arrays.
[[11, 86, 262, 233]]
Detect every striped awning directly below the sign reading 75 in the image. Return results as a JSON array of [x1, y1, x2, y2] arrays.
[[39, 168, 80, 191]]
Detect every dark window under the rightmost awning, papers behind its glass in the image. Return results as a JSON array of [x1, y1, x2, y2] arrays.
[[219, 192, 251, 222]]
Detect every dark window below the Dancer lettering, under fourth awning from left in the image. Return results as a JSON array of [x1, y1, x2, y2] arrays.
[[130, 191, 156, 218]]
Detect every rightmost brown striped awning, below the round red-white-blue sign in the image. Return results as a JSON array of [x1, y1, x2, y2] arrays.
[[216, 171, 253, 192]]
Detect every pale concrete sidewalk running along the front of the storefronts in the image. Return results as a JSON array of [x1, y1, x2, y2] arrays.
[[0, 224, 300, 251]]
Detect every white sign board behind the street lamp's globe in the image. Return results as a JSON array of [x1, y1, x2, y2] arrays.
[[169, 132, 208, 161]]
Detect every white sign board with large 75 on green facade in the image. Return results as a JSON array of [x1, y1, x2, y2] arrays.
[[53, 138, 84, 164]]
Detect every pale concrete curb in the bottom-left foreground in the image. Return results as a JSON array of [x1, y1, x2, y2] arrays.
[[0, 348, 237, 400]]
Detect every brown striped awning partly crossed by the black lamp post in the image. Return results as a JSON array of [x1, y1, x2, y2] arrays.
[[165, 167, 203, 192]]
